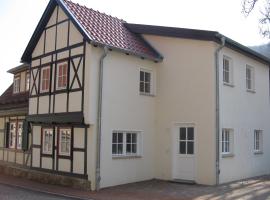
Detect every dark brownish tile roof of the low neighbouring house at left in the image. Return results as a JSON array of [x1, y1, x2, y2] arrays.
[[0, 84, 29, 110]]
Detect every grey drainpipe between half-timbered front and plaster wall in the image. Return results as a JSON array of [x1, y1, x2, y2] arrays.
[[96, 46, 108, 190]]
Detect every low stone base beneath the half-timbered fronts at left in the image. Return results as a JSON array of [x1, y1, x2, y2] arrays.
[[0, 161, 91, 190]]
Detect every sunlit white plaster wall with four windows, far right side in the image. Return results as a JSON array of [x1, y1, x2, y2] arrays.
[[220, 48, 270, 183]]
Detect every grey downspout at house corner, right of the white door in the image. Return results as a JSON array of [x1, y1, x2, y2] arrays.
[[215, 36, 225, 185]]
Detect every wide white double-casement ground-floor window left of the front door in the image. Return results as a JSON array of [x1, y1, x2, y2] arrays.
[[112, 131, 140, 156]]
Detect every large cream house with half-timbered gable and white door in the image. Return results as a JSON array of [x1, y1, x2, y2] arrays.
[[0, 0, 270, 189]]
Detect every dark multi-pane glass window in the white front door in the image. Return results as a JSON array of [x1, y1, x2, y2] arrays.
[[179, 127, 194, 155]]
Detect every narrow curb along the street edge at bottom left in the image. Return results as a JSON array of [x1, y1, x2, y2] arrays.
[[0, 181, 94, 200]]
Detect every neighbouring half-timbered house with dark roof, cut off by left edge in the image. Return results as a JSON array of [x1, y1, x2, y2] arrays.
[[0, 64, 31, 166]]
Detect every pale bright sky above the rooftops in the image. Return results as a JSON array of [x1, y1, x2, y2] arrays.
[[0, 0, 268, 94]]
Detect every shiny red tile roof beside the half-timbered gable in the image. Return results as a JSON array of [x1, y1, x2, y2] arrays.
[[62, 0, 161, 60]]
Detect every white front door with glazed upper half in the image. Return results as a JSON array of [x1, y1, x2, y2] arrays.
[[173, 125, 196, 181]]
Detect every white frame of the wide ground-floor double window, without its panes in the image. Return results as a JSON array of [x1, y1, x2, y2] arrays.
[[111, 130, 142, 158]]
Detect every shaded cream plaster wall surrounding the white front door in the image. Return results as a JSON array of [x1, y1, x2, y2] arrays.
[[144, 35, 216, 185]]
